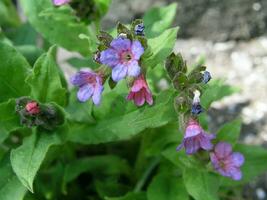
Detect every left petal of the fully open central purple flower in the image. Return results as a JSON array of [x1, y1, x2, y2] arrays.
[[100, 49, 119, 67]]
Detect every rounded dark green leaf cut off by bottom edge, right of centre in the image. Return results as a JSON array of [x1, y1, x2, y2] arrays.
[[147, 173, 189, 200]]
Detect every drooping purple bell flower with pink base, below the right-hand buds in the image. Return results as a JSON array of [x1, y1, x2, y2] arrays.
[[176, 119, 215, 154]]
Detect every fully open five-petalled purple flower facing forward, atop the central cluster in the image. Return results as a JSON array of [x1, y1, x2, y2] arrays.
[[100, 37, 144, 82]]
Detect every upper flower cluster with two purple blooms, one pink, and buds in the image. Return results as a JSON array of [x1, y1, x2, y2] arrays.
[[70, 22, 153, 106]]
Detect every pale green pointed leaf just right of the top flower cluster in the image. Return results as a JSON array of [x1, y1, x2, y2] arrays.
[[142, 27, 178, 68]]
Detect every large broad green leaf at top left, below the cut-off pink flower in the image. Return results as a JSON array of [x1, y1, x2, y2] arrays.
[[21, 0, 96, 55]]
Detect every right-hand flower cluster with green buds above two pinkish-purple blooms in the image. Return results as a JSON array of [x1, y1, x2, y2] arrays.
[[169, 54, 244, 180]]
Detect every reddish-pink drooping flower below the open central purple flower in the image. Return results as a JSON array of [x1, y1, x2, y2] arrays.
[[127, 74, 153, 106]]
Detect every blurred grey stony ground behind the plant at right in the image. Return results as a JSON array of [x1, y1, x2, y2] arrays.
[[103, 0, 267, 200]]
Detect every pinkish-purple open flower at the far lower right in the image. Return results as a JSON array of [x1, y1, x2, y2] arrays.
[[210, 142, 245, 180]]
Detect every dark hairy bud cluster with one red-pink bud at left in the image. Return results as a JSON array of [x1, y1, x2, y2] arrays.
[[15, 97, 64, 130]]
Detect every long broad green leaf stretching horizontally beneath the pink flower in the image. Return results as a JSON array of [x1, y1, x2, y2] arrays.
[[67, 91, 176, 144]]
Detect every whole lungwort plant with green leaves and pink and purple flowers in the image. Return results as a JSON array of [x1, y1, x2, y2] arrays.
[[0, 0, 267, 200]]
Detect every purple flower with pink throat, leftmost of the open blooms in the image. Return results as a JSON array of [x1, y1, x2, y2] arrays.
[[71, 71, 104, 105]]
